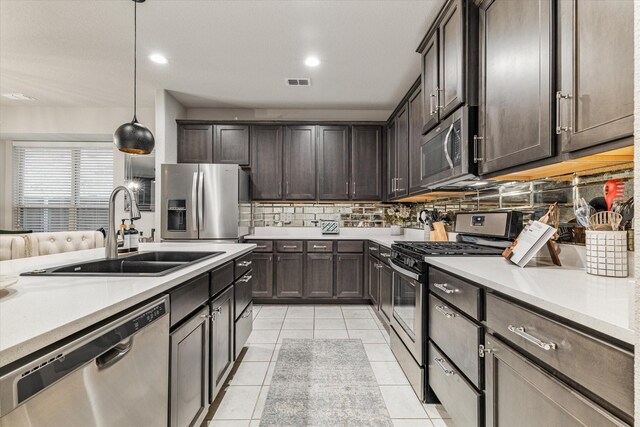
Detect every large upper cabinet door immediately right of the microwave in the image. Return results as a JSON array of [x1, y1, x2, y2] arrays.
[[479, 0, 554, 174]]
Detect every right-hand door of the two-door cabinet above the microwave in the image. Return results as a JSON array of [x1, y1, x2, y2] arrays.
[[438, 0, 464, 118]]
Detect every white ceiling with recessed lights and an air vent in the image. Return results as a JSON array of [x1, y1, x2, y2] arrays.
[[0, 0, 444, 110]]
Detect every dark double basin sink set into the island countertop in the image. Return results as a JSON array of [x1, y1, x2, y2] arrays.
[[22, 251, 224, 277]]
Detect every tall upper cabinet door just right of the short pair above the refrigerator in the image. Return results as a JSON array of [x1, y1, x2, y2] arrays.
[[251, 126, 284, 200]]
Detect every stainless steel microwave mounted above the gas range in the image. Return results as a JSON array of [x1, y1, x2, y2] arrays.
[[420, 106, 478, 189]]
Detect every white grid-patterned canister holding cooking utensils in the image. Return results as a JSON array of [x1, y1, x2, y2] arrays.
[[585, 230, 629, 277]]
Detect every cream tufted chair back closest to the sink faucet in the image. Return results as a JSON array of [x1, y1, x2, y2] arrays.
[[24, 231, 104, 256]]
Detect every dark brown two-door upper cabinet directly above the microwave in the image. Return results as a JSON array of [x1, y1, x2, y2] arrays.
[[418, 0, 478, 133]]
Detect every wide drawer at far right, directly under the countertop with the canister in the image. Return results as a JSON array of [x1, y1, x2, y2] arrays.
[[487, 294, 633, 416]]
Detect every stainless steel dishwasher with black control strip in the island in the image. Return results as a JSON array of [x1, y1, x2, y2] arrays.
[[0, 297, 169, 427]]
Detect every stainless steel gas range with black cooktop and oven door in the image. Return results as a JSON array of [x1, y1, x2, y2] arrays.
[[390, 212, 522, 402]]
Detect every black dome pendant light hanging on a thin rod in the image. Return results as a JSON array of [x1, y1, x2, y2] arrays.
[[113, 0, 156, 154]]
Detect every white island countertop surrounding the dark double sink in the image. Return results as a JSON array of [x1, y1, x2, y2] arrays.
[[0, 243, 255, 366]]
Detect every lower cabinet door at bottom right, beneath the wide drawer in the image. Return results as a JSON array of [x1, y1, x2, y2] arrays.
[[485, 335, 626, 427]]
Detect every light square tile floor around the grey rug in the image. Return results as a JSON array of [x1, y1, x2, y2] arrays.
[[203, 305, 453, 427]]
